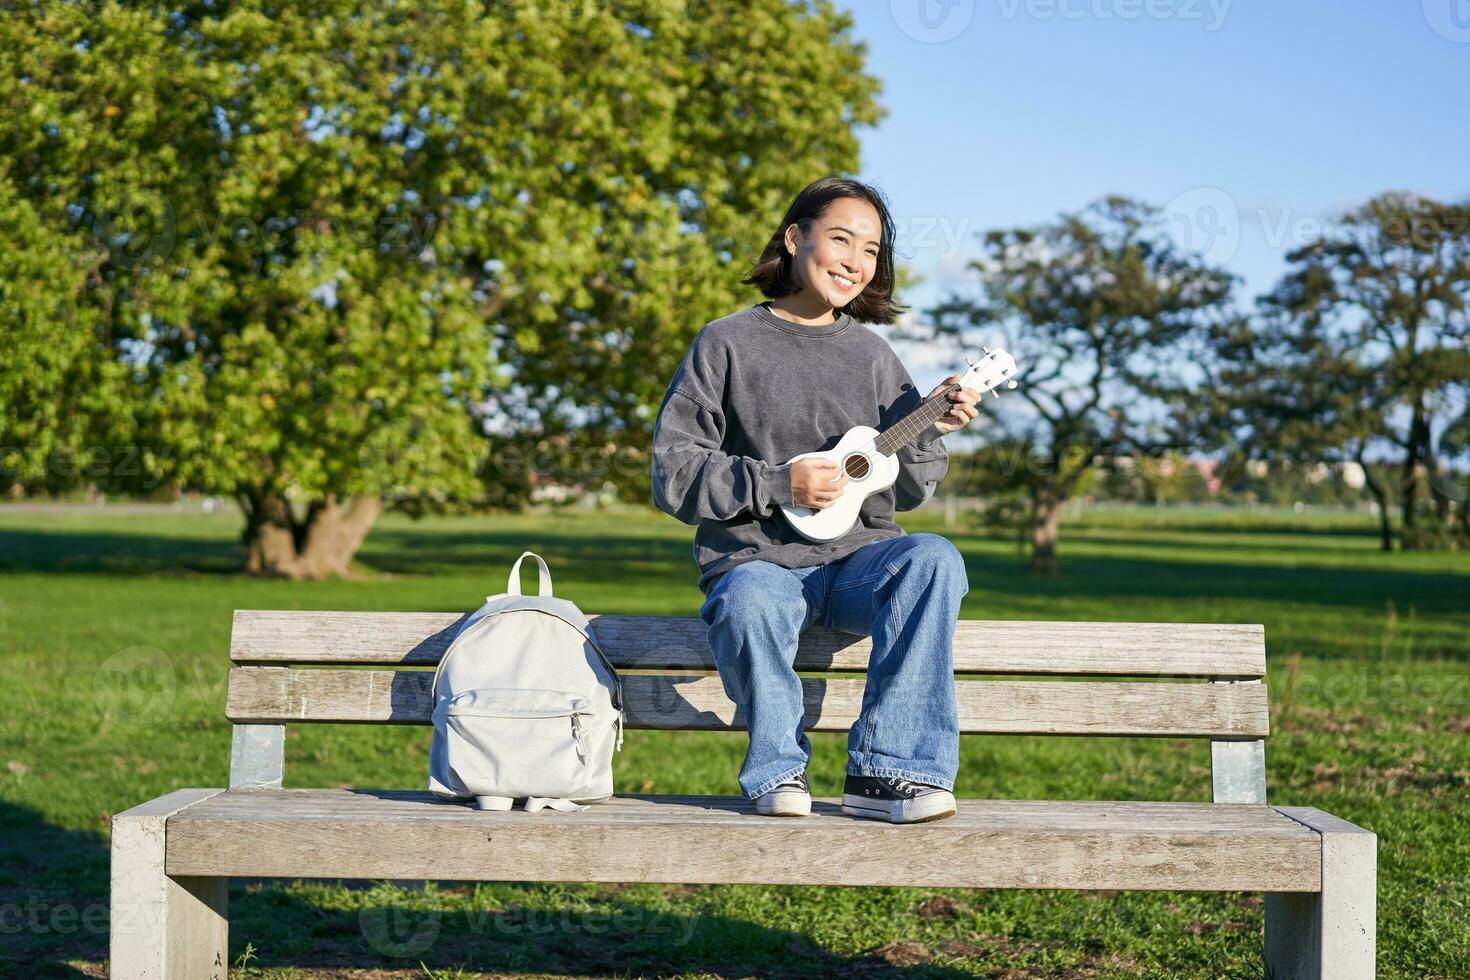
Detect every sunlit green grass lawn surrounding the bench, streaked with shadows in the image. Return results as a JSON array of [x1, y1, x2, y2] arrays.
[[0, 507, 1470, 977]]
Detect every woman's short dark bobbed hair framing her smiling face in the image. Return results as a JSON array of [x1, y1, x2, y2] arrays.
[[741, 176, 908, 323]]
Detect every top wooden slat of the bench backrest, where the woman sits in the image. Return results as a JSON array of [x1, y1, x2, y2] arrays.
[[229, 610, 1266, 677]]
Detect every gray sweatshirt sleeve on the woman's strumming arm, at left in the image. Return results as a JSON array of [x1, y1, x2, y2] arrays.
[[651, 351, 792, 525]]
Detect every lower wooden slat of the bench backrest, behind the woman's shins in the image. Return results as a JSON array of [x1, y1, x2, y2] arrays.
[[225, 667, 1267, 739]]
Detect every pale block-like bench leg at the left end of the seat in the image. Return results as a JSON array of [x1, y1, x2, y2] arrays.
[[109, 789, 229, 980]]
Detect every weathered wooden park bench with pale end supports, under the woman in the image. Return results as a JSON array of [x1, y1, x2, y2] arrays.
[[110, 611, 1376, 980]]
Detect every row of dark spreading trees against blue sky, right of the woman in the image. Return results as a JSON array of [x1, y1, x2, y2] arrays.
[[908, 192, 1470, 572]]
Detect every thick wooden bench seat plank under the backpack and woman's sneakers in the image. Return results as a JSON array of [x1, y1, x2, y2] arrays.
[[168, 790, 1322, 892]]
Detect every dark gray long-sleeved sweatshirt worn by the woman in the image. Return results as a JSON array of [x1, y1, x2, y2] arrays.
[[653, 303, 950, 595]]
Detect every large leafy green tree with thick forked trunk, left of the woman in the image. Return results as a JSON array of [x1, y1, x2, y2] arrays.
[[0, 0, 879, 576]]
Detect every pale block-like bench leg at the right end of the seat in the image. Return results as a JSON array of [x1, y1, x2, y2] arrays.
[[1266, 807, 1377, 980]]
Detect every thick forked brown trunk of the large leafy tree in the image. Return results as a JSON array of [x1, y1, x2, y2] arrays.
[[240, 492, 382, 579]]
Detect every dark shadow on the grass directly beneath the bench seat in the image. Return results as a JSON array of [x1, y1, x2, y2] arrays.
[[231, 882, 973, 979]]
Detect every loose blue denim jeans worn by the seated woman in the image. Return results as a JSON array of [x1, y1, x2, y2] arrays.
[[700, 533, 970, 799]]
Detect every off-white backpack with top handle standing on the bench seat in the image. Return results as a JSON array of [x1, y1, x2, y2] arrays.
[[429, 551, 623, 811]]
